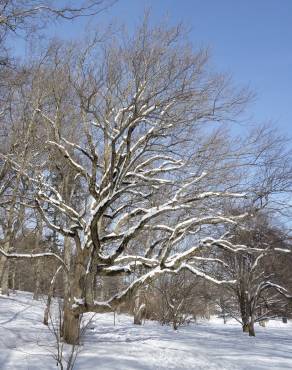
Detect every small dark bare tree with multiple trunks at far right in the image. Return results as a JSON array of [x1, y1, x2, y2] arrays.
[[209, 214, 291, 336]]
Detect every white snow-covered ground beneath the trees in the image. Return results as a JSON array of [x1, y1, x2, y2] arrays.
[[0, 293, 292, 370]]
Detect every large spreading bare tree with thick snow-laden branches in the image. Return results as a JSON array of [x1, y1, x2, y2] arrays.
[[1, 21, 278, 343]]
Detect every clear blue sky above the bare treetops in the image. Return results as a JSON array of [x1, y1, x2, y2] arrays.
[[16, 0, 292, 136]]
